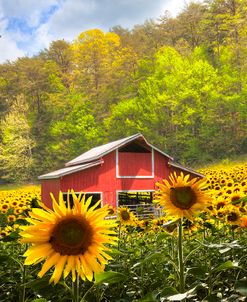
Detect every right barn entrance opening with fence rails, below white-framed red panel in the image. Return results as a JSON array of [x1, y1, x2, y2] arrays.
[[118, 191, 159, 219]]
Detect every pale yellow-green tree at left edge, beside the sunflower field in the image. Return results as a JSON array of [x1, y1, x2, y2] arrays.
[[0, 95, 35, 181]]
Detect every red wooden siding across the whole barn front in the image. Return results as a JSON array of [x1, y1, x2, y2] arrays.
[[42, 150, 199, 206]]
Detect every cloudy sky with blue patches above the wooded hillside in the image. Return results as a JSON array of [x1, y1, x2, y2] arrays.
[[0, 0, 186, 63]]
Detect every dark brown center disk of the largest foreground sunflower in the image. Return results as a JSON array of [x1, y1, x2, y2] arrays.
[[49, 217, 93, 255]]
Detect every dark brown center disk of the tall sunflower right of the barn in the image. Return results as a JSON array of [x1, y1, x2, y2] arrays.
[[170, 186, 196, 210]]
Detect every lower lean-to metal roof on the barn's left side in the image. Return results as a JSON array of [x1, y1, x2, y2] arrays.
[[38, 160, 104, 179]]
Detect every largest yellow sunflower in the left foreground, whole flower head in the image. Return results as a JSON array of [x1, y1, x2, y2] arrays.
[[21, 191, 116, 284]]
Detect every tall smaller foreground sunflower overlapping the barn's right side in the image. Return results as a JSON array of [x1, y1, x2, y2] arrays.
[[154, 172, 211, 219]]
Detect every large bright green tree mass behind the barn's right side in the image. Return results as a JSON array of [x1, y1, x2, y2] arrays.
[[105, 47, 245, 163]]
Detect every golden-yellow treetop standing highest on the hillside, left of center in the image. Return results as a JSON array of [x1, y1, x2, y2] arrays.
[[72, 29, 136, 114]]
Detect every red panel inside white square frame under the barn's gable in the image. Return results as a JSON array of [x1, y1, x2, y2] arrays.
[[118, 152, 152, 177]]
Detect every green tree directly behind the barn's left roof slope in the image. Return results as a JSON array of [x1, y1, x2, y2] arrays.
[[46, 93, 103, 167]]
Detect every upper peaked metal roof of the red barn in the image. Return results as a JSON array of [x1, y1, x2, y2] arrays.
[[65, 133, 173, 167]]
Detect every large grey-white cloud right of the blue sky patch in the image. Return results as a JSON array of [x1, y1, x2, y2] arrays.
[[46, 0, 169, 39]]
